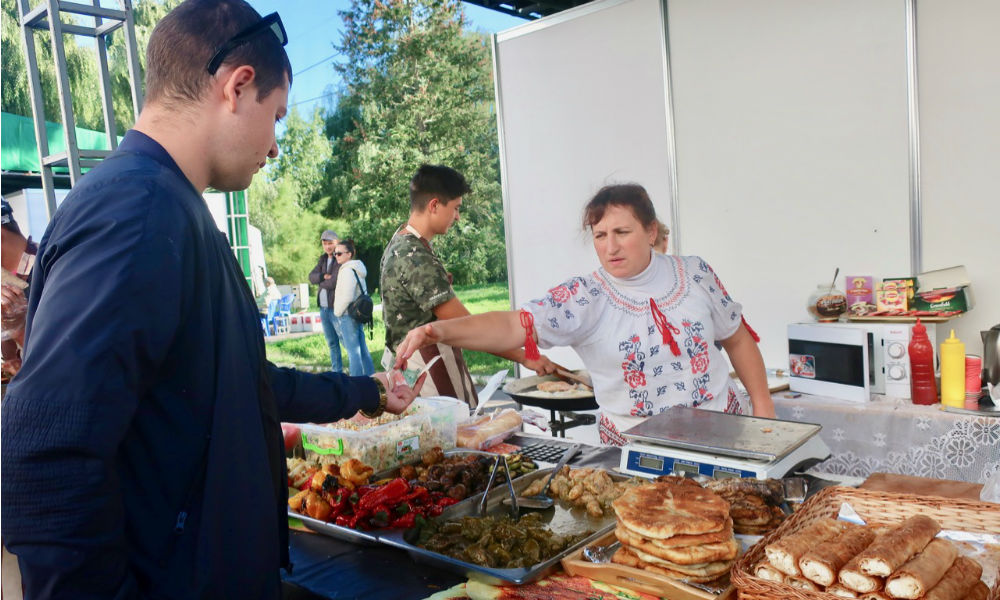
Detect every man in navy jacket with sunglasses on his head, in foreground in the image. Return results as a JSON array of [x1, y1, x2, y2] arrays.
[[0, 0, 420, 599]]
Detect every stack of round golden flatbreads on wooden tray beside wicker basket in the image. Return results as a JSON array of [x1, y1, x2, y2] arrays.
[[611, 479, 739, 583]]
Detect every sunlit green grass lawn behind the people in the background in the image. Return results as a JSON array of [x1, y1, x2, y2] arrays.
[[267, 283, 514, 375]]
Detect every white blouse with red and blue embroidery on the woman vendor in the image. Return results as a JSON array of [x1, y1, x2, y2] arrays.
[[521, 252, 749, 431]]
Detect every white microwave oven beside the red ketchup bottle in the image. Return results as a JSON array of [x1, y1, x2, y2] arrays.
[[788, 322, 937, 402]]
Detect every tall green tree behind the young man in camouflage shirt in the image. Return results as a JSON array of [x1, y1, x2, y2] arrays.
[[331, 0, 506, 283]]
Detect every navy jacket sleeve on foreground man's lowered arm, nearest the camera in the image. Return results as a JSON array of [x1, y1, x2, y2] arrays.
[[2, 181, 183, 598]]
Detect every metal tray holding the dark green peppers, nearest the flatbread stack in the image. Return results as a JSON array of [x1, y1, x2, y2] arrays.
[[379, 469, 629, 585]]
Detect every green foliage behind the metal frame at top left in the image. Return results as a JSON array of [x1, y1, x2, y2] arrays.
[[0, 0, 180, 135]]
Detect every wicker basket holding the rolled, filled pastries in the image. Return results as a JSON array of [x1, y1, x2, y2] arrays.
[[732, 487, 1000, 600]]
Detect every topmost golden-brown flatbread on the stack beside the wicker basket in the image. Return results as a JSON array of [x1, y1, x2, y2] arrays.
[[611, 483, 729, 539]]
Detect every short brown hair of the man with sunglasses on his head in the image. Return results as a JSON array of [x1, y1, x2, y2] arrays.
[[146, 0, 292, 104]]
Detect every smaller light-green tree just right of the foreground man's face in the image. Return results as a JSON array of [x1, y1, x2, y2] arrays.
[[270, 107, 332, 208]]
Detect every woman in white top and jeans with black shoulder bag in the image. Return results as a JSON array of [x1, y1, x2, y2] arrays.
[[333, 240, 375, 375]]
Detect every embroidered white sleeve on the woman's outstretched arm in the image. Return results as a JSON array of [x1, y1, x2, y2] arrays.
[[521, 277, 601, 348]]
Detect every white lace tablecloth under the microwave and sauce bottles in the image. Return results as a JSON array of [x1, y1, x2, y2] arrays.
[[772, 392, 1000, 483]]
